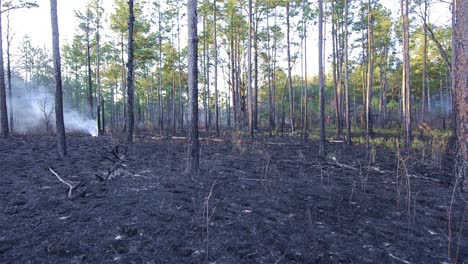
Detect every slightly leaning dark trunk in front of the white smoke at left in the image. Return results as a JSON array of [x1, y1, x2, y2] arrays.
[[49, 0, 67, 157]]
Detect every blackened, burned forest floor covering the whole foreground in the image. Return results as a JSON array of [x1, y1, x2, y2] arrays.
[[0, 135, 468, 264]]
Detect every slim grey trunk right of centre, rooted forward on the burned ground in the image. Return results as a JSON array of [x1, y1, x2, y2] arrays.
[[318, 0, 325, 157]]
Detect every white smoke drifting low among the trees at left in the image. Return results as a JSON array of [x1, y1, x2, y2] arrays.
[[9, 84, 97, 136]]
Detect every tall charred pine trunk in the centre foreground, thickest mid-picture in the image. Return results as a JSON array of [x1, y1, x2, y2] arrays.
[[187, 0, 200, 173]]
